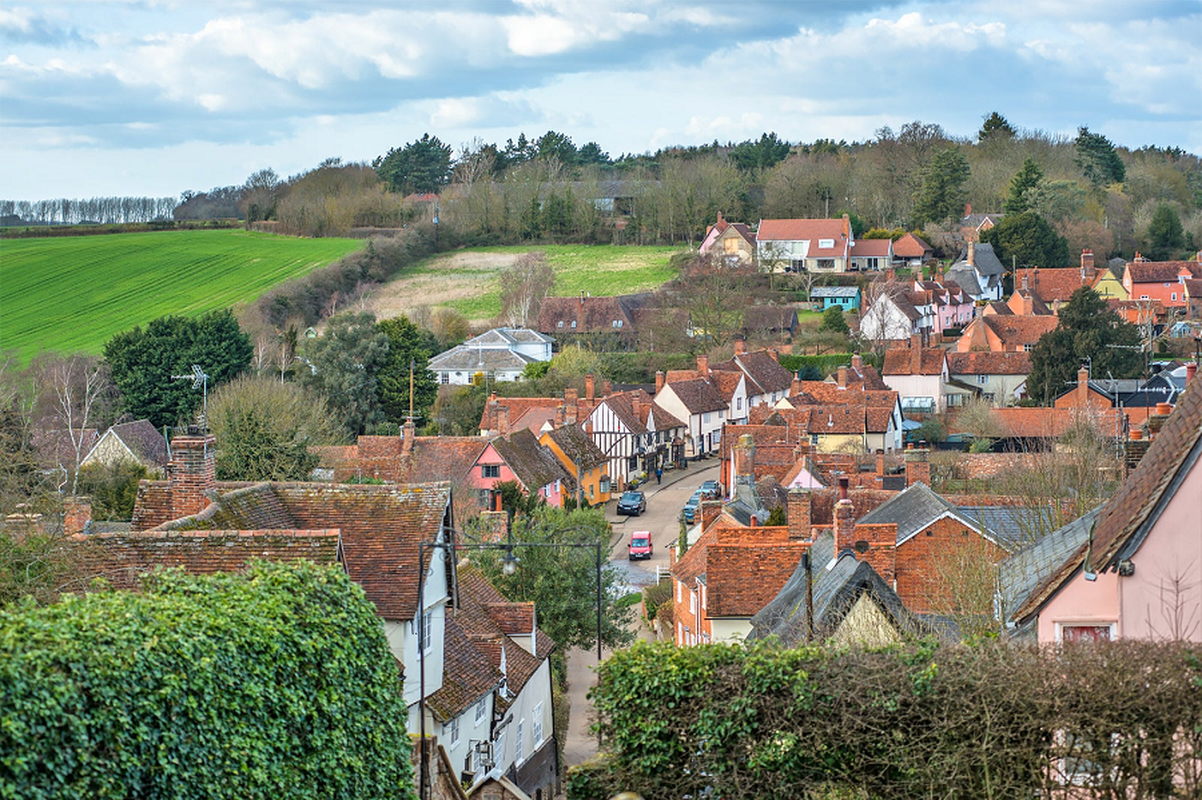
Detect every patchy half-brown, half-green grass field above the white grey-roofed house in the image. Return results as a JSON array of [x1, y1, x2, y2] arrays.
[[367, 245, 679, 322]]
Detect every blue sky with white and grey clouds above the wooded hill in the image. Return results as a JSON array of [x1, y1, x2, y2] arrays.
[[0, 0, 1202, 201]]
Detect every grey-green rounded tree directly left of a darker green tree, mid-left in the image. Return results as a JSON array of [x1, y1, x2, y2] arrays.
[[304, 312, 388, 436]]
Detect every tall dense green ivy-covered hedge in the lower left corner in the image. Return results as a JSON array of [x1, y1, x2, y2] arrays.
[[0, 562, 413, 800]]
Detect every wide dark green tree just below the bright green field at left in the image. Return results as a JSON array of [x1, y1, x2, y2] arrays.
[[105, 309, 255, 428]]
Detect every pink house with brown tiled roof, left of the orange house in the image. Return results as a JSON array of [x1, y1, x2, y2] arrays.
[[468, 429, 576, 508]]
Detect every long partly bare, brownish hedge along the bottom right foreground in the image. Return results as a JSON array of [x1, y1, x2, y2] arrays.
[[567, 640, 1202, 800]]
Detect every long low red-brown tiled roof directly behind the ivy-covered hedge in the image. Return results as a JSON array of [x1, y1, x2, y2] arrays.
[[71, 530, 339, 590]]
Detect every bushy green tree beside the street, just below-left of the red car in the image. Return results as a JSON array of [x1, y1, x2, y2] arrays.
[[459, 505, 633, 649]]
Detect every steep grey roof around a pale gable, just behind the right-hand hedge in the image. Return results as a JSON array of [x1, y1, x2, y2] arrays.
[[748, 531, 916, 646]]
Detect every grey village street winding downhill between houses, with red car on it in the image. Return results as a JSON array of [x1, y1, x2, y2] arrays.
[[564, 459, 719, 772]]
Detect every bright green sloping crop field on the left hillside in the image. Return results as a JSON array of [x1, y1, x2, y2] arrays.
[[0, 225, 363, 363]]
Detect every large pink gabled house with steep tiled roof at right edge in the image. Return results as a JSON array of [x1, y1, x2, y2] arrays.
[[1002, 369, 1202, 643]]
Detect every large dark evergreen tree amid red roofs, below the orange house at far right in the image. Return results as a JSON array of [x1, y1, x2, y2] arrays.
[[1027, 287, 1143, 405]]
